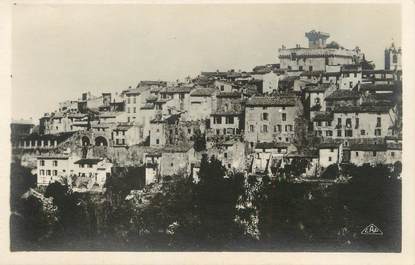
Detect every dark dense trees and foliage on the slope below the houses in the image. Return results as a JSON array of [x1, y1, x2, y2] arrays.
[[11, 160, 401, 251]]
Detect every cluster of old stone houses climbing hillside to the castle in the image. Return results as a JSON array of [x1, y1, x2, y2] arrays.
[[12, 30, 402, 188]]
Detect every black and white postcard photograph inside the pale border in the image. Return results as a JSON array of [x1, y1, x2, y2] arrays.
[[2, 1, 413, 264]]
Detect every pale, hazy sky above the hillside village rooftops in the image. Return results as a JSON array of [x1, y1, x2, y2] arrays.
[[12, 4, 401, 119]]
